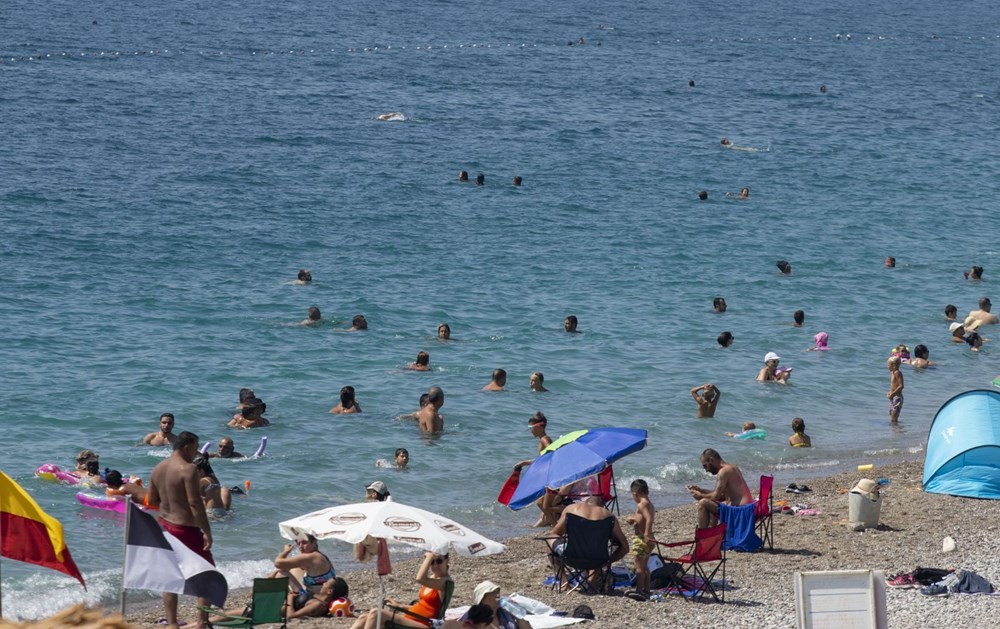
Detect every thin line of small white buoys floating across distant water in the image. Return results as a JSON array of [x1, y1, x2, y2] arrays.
[[0, 33, 1000, 64]]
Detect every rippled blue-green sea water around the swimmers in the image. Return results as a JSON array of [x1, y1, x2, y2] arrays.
[[0, 0, 1000, 618]]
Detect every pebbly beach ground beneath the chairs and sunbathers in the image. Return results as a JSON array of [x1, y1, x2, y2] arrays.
[[117, 460, 1000, 629]]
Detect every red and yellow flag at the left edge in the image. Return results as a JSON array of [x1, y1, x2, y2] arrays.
[[0, 472, 87, 589]]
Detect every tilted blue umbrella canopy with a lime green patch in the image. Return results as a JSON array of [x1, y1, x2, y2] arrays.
[[509, 428, 646, 510]]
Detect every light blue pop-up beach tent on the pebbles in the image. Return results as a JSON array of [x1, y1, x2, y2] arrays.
[[924, 389, 1000, 500]]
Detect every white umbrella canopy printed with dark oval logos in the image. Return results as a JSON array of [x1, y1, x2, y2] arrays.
[[278, 501, 506, 557]]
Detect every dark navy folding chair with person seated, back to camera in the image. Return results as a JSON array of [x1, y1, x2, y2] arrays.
[[539, 513, 617, 594]]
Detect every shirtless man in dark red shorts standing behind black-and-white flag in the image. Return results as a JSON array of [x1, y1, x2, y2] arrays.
[[148, 431, 215, 629]]
